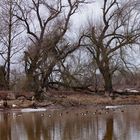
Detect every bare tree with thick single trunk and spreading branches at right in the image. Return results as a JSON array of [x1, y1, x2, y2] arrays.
[[84, 0, 140, 93]]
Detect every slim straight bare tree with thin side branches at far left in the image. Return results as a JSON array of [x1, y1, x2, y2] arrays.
[[0, 0, 22, 89]]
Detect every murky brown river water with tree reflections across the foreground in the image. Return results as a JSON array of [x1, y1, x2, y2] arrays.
[[0, 106, 140, 140]]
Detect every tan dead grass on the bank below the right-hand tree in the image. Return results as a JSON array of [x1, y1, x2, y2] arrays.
[[49, 94, 140, 106]]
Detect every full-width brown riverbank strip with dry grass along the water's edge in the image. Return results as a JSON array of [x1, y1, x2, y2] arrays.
[[0, 92, 140, 109]]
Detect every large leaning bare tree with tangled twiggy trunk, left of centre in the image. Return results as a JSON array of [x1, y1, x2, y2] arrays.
[[15, 0, 91, 97]]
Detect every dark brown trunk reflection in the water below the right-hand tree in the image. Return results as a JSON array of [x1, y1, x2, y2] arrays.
[[103, 117, 113, 140]]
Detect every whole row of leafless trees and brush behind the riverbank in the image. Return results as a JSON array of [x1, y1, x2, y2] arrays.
[[0, 0, 140, 97]]
